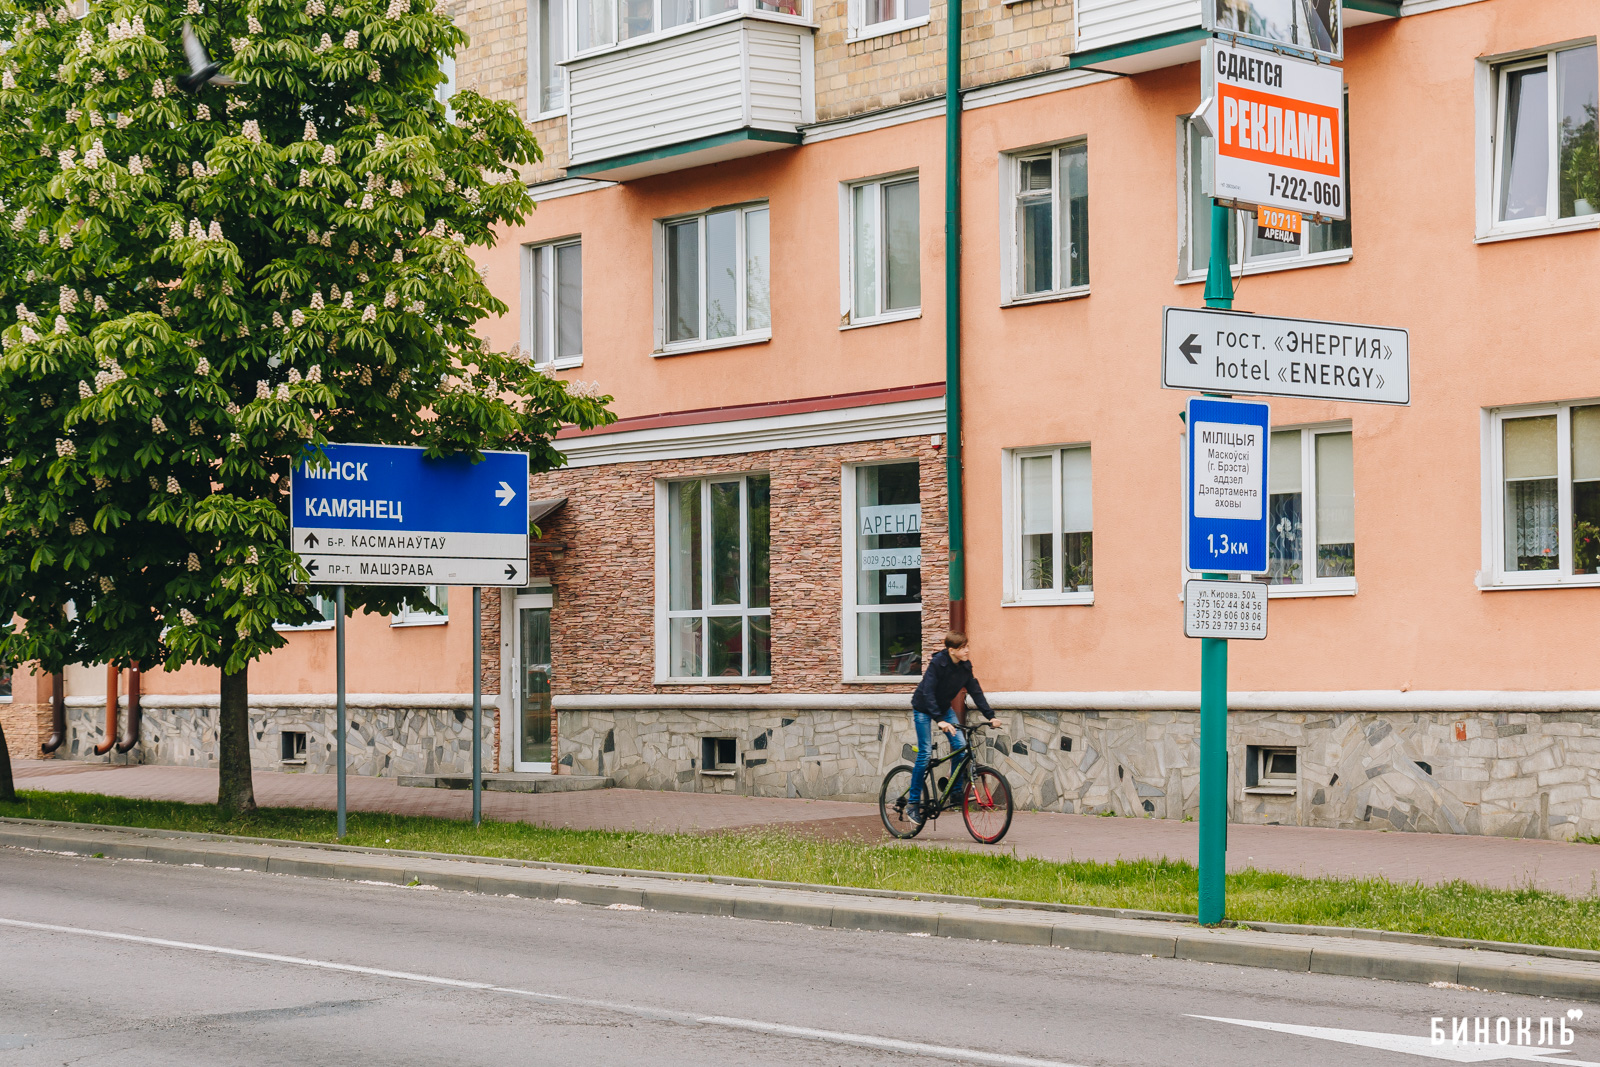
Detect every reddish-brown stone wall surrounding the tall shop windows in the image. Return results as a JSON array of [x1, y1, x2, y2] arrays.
[[518, 437, 949, 699]]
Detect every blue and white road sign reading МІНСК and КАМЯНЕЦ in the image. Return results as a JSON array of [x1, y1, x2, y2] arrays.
[[290, 445, 528, 585]]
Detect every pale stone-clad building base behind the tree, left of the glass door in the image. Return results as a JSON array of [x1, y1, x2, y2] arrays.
[[60, 702, 494, 777]]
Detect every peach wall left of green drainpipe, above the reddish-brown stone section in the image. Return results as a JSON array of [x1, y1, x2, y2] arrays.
[[482, 120, 944, 416]]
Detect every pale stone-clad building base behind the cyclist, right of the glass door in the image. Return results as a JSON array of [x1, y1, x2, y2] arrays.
[[558, 710, 1600, 840]]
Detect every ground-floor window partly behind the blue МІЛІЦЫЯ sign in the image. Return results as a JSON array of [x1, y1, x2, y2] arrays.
[[1267, 426, 1355, 592]]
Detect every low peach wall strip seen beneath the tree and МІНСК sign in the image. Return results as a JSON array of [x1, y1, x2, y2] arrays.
[[138, 589, 472, 694]]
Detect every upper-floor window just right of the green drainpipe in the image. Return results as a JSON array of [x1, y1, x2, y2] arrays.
[[1010, 142, 1090, 299]]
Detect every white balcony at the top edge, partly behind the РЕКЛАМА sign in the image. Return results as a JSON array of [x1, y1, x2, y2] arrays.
[[1072, 0, 1400, 74]]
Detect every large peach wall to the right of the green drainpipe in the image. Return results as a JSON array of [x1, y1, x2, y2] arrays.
[[963, 0, 1600, 691]]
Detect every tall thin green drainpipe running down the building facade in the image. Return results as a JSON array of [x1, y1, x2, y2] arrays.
[[944, 0, 966, 630]]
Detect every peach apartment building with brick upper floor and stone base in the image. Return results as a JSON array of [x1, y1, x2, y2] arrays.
[[18, 0, 1600, 838]]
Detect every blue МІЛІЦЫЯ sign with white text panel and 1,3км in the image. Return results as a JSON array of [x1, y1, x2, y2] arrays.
[[1184, 397, 1272, 574]]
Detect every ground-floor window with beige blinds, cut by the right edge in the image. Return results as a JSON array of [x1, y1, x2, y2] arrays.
[[1485, 402, 1600, 585]]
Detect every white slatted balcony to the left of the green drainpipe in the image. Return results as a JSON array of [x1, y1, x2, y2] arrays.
[[566, 9, 814, 181]]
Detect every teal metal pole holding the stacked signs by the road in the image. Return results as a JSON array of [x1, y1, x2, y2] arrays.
[[1200, 202, 1234, 926]]
